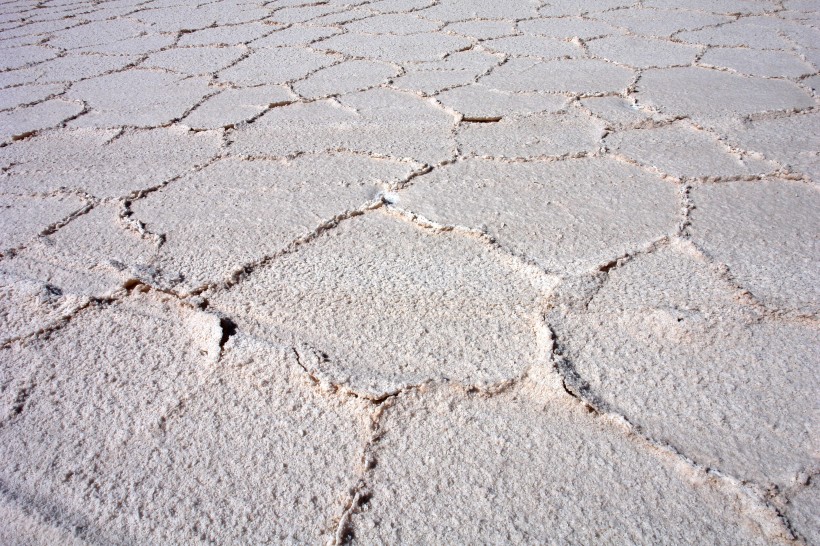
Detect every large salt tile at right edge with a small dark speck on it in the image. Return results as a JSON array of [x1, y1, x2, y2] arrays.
[[548, 242, 820, 486]]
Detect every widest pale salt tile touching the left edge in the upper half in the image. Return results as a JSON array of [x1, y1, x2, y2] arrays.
[[0, 127, 221, 197]]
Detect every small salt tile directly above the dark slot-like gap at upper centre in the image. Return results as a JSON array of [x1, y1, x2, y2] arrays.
[[436, 84, 567, 121]]
